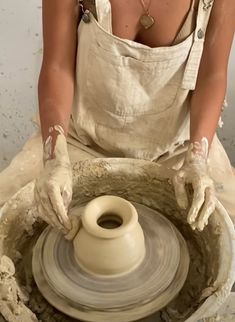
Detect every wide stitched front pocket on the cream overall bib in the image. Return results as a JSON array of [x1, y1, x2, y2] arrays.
[[85, 43, 180, 117]]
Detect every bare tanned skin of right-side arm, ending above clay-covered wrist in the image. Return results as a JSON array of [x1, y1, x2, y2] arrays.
[[190, 0, 235, 146]]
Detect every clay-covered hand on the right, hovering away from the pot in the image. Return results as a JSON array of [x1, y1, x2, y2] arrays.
[[173, 138, 216, 231]]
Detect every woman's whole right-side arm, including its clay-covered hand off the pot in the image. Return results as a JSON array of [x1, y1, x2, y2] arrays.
[[173, 0, 235, 230]]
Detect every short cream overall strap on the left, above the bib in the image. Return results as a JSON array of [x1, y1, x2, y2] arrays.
[[95, 0, 112, 34]]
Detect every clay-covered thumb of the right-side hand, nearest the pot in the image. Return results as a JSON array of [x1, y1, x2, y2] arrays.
[[173, 171, 188, 209]]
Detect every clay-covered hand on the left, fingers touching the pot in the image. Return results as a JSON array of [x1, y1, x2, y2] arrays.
[[34, 128, 72, 234]]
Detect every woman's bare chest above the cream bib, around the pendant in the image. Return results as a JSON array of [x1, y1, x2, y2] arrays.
[[84, 0, 200, 47]]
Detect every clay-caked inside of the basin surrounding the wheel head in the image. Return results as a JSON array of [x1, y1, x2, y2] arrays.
[[0, 159, 234, 322]]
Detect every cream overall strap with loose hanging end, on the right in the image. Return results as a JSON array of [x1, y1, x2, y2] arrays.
[[182, 0, 214, 90]]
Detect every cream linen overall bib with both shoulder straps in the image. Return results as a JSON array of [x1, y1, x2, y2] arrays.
[[72, 0, 213, 161]]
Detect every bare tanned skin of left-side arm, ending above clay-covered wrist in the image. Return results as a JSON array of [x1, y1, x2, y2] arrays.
[[38, 0, 80, 150]]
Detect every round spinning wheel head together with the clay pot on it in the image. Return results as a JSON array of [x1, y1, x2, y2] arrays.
[[33, 196, 189, 322]]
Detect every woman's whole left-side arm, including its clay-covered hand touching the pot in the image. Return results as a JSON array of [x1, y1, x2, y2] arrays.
[[34, 0, 80, 234]]
